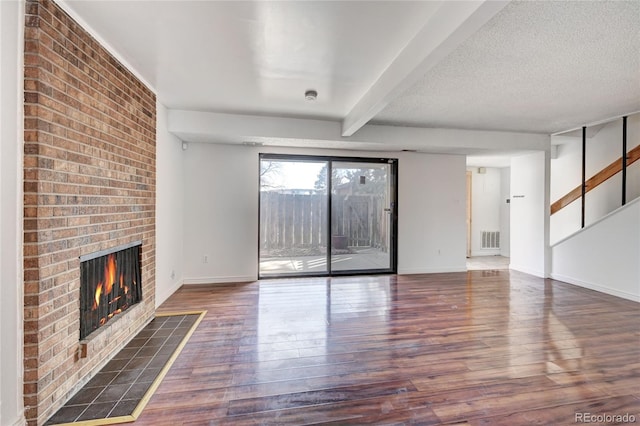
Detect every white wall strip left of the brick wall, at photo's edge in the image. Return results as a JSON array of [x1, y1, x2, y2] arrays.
[[0, 1, 25, 426]]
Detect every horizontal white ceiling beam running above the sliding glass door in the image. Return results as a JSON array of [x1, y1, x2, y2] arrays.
[[168, 109, 549, 155]]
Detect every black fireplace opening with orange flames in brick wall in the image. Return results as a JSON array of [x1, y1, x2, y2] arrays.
[[80, 242, 142, 340]]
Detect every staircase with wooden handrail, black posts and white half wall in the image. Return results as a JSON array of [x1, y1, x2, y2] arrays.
[[550, 114, 640, 302]]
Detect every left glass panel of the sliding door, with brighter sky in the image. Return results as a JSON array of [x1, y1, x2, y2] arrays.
[[259, 157, 329, 277]]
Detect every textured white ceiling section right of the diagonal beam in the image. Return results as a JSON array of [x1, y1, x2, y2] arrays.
[[373, 1, 640, 133]]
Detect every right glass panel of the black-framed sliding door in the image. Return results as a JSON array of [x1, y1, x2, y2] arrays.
[[330, 161, 395, 273]]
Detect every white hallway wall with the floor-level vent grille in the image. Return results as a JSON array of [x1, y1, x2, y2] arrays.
[[467, 167, 504, 256]]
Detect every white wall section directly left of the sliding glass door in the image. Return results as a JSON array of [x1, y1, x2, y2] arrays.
[[183, 143, 259, 284]]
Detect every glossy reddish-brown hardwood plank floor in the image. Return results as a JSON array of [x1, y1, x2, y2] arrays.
[[136, 271, 640, 425]]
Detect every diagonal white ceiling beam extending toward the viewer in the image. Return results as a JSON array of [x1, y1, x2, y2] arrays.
[[342, 0, 509, 136]]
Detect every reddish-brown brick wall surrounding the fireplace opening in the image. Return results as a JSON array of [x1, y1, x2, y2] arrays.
[[24, 0, 156, 425]]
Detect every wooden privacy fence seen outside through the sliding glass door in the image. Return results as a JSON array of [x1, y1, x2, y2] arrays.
[[260, 191, 390, 251]]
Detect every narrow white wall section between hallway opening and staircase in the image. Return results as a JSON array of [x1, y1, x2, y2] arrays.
[[510, 151, 549, 277]]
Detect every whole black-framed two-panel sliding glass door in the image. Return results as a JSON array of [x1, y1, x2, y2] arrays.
[[259, 154, 397, 277]]
